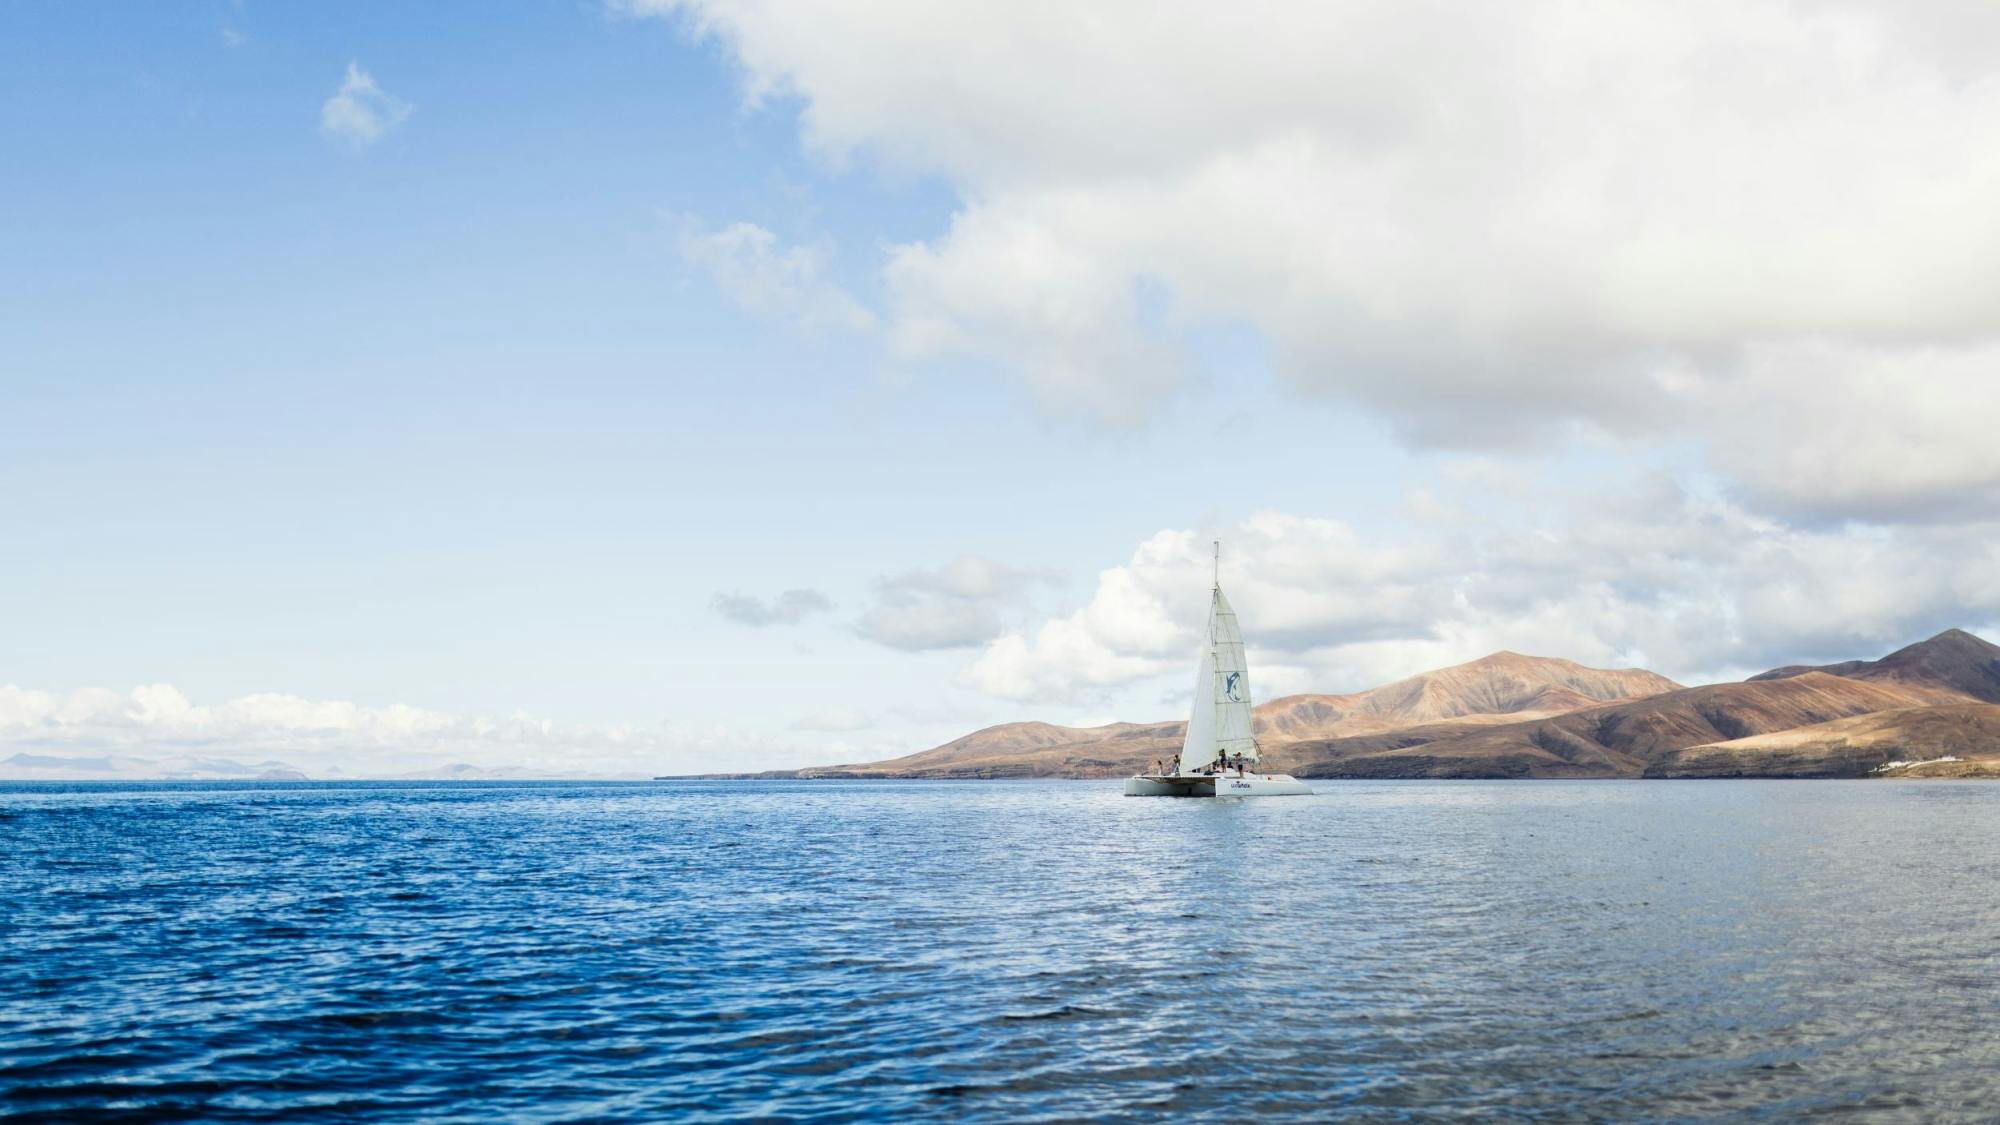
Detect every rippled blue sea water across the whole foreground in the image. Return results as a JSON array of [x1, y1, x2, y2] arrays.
[[0, 781, 2000, 1121]]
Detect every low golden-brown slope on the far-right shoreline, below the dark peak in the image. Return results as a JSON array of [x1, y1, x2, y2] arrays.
[[1646, 703, 2000, 777]]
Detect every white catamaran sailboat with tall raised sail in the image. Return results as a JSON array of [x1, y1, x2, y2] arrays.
[[1126, 540, 1312, 797]]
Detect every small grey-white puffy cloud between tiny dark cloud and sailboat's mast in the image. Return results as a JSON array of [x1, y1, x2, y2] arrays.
[[856, 554, 1052, 653]]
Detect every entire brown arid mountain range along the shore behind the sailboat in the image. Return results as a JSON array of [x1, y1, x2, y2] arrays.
[[796, 629, 2000, 779]]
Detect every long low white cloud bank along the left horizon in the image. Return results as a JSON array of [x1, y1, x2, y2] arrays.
[[0, 685, 826, 777]]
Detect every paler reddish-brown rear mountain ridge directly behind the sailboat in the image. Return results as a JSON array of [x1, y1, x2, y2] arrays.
[[800, 653, 1680, 777]]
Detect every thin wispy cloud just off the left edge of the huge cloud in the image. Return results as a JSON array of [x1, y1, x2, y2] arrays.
[[680, 218, 876, 332]]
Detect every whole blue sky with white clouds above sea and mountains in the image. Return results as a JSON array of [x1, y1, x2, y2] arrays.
[[0, 0, 2000, 773]]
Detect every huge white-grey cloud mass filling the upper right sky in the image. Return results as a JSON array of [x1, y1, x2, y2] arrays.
[[622, 0, 2000, 518]]
